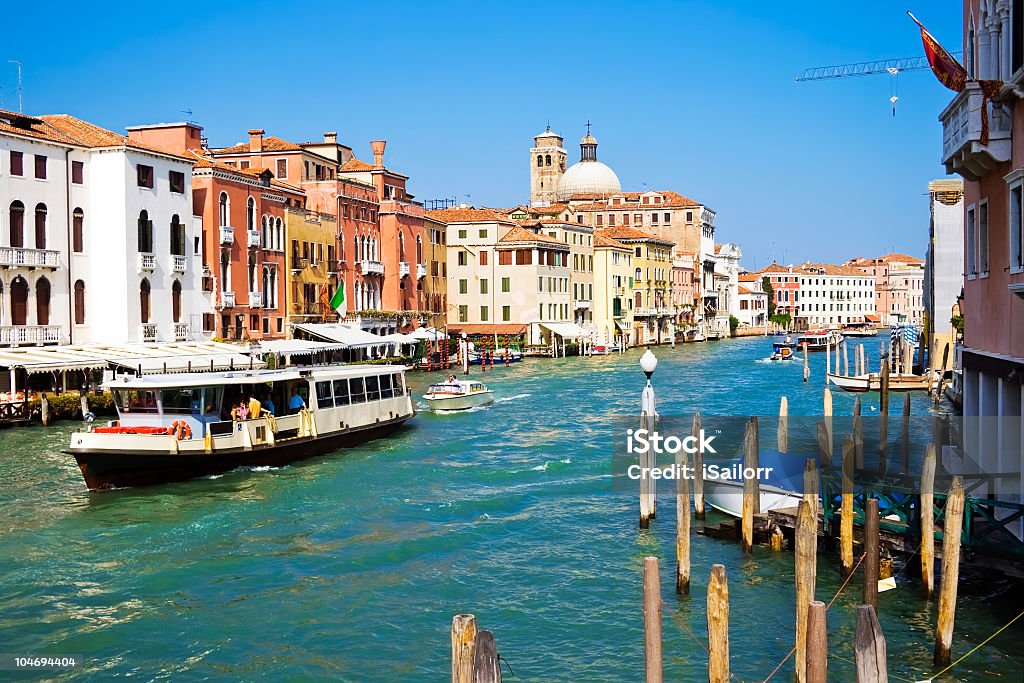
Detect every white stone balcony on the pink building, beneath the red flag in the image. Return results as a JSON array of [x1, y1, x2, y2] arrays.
[[939, 82, 1012, 180]]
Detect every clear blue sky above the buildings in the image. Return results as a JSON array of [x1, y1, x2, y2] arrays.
[[0, 0, 963, 268]]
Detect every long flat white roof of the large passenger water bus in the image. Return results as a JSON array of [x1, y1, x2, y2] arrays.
[[104, 365, 407, 389]]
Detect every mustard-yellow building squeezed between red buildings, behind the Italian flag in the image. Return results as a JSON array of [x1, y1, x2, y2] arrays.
[[285, 208, 340, 324]]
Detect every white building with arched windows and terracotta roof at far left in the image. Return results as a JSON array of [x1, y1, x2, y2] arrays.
[[0, 112, 209, 345]]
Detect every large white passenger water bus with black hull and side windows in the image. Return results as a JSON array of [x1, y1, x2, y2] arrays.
[[68, 366, 415, 488]]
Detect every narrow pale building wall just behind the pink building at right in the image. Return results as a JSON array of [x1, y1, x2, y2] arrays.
[[924, 178, 964, 369]]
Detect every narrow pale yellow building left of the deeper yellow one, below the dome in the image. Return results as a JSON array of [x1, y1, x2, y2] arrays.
[[593, 233, 634, 346]]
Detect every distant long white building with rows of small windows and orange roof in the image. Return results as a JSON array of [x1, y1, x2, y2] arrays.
[[794, 263, 876, 328]]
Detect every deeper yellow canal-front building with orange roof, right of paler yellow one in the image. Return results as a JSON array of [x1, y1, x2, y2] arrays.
[[596, 225, 675, 344]]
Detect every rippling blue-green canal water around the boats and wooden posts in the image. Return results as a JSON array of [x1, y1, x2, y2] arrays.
[[0, 338, 1024, 681]]
